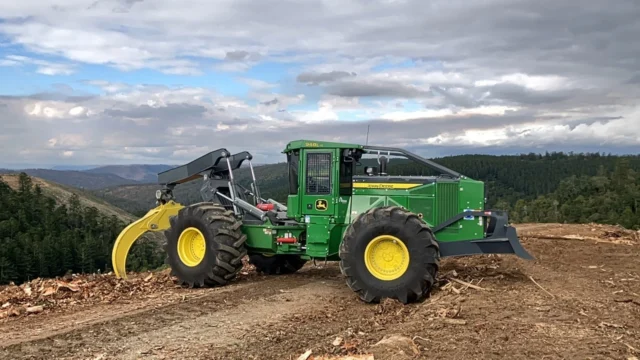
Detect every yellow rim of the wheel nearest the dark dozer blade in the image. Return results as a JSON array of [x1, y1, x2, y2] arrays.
[[364, 235, 409, 281]]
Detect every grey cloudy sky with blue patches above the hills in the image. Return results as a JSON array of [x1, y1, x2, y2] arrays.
[[0, 0, 640, 167]]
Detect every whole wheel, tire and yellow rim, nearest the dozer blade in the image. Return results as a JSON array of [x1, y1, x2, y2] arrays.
[[340, 206, 440, 304]]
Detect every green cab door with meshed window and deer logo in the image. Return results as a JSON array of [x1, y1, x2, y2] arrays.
[[300, 149, 338, 217]]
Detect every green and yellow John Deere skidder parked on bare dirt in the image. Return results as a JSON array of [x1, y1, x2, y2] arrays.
[[112, 140, 532, 304]]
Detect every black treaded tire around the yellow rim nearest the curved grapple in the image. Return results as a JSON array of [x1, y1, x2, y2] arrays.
[[165, 203, 247, 287]]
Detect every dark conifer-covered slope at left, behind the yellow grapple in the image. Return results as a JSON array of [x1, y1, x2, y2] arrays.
[[0, 173, 163, 284]]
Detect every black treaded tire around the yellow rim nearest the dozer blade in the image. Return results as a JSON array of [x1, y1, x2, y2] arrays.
[[339, 206, 440, 304]]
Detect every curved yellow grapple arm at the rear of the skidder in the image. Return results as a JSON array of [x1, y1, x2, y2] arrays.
[[111, 201, 184, 279]]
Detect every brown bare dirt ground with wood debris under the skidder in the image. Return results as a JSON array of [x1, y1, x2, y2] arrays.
[[0, 224, 640, 360]]
